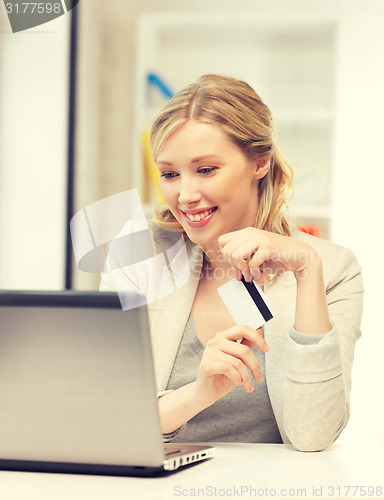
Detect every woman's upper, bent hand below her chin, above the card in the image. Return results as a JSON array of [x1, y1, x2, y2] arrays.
[[218, 227, 319, 282]]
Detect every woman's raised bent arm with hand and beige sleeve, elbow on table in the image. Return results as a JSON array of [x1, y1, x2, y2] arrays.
[[219, 228, 363, 451]]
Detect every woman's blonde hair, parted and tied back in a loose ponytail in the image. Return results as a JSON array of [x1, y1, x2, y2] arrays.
[[151, 75, 294, 236]]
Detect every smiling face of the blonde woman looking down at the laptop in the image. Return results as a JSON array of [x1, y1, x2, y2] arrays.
[[156, 120, 265, 249]]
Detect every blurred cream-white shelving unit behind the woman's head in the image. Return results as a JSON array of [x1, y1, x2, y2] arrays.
[[133, 14, 338, 238]]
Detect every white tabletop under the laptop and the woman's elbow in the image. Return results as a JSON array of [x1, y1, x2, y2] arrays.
[[0, 443, 384, 500]]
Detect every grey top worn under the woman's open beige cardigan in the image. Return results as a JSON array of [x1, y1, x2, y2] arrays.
[[167, 315, 282, 443]]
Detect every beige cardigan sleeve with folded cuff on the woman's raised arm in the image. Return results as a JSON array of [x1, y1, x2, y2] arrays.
[[283, 249, 363, 451]]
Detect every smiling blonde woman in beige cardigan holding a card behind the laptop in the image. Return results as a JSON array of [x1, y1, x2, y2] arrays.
[[100, 75, 362, 451]]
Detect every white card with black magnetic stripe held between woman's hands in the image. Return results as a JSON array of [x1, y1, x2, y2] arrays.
[[217, 278, 274, 329]]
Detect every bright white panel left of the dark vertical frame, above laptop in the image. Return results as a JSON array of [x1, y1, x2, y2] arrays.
[[0, 10, 70, 289]]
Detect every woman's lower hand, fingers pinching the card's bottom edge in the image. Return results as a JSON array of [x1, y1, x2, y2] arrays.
[[195, 325, 269, 406]]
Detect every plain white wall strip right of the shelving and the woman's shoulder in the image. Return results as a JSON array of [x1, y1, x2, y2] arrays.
[[332, 0, 384, 447]]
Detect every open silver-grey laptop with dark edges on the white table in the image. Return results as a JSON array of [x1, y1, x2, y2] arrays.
[[0, 291, 215, 475]]
